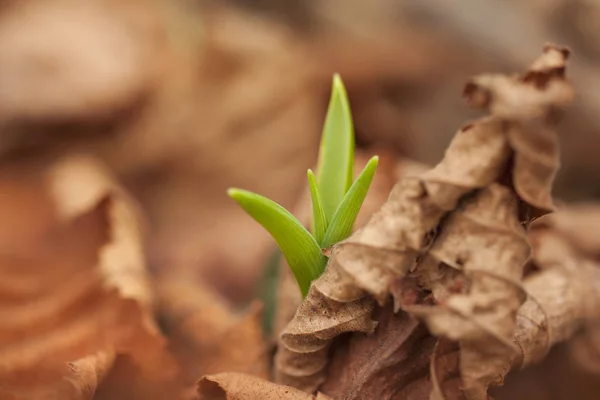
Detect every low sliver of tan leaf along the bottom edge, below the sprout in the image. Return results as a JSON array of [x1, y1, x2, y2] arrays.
[[198, 373, 331, 400]]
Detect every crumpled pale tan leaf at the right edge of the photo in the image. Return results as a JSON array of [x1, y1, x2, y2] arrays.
[[513, 206, 600, 372]]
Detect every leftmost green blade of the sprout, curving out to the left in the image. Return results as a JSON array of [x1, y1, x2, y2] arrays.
[[227, 189, 326, 296]]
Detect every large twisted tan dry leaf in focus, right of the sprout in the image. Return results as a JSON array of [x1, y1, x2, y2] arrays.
[[276, 46, 572, 399]]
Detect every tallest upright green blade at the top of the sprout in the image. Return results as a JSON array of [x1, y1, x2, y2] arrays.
[[317, 74, 354, 222]]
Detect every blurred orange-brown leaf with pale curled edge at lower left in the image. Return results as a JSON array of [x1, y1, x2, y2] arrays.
[[0, 158, 174, 399]]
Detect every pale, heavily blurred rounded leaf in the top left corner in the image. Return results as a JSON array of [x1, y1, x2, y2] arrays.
[[0, 0, 167, 126]]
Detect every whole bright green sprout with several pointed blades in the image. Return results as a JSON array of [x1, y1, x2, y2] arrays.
[[227, 74, 379, 296]]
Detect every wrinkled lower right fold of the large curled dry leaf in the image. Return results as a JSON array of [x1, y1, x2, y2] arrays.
[[404, 185, 529, 398]]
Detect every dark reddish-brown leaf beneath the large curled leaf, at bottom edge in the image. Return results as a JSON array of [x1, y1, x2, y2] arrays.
[[320, 305, 436, 400]]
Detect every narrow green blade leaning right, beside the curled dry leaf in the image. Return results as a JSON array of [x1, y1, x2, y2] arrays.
[[321, 156, 379, 248]]
